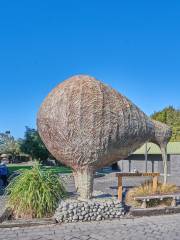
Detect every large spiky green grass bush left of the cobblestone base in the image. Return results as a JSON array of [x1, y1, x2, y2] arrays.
[[6, 163, 66, 218]]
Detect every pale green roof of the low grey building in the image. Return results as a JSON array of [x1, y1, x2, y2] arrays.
[[133, 142, 180, 154]]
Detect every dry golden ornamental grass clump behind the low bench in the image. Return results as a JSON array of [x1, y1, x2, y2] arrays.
[[126, 181, 178, 207]]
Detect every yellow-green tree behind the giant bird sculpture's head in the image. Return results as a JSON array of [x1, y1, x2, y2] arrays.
[[151, 106, 180, 142]]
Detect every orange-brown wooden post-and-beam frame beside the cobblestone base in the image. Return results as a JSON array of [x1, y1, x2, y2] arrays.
[[116, 172, 160, 202]]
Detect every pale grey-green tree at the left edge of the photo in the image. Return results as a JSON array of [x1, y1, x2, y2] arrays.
[[0, 131, 20, 160]]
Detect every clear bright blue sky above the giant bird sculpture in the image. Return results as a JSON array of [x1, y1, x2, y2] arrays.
[[0, 0, 180, 137]]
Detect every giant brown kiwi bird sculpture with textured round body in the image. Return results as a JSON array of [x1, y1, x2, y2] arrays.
[[37, 75, 171, 199]]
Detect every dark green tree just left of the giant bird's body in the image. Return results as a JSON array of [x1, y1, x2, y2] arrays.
[[20, 127, 51, 161]]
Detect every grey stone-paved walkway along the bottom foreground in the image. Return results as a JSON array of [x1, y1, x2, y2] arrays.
[[0, 214, 180, 240]]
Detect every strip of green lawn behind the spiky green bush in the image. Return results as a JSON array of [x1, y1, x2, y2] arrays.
[[8, 164, 72, 174]]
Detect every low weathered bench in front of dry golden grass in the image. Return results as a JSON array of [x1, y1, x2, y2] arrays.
[[134, 193, 180, 208]]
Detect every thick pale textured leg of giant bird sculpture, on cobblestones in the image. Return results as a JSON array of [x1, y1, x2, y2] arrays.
[[73, 169, 94, 200]]
